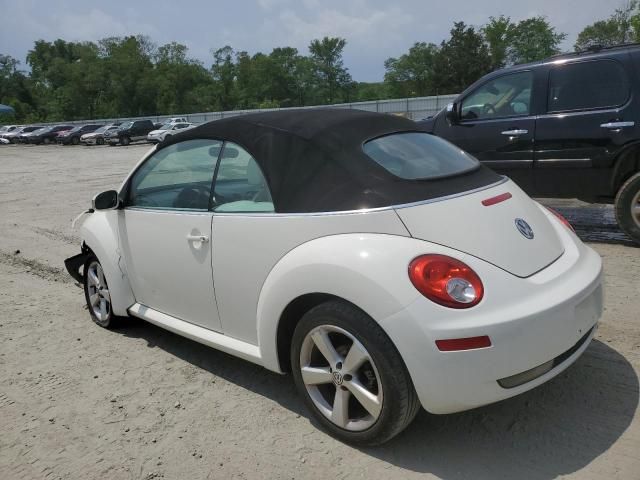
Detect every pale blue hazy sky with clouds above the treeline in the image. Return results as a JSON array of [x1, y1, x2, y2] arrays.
[[0, 0, 624, 82]]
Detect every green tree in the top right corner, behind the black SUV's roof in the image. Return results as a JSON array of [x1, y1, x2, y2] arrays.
[[574, 0, 640, 51]]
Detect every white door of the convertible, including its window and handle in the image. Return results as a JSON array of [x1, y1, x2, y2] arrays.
[[119, 140, 222, 330]]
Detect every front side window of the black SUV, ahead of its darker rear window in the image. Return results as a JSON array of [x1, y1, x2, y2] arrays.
[[461, 72, 533, 120]]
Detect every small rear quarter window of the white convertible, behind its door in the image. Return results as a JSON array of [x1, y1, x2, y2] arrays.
[[213, 142, 274, 213]]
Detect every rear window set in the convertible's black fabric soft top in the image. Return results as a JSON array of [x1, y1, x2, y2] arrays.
[[363, 132, 480, 180]]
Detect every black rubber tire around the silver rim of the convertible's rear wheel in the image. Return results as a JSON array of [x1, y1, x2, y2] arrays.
[[291, 300, 420, 446]]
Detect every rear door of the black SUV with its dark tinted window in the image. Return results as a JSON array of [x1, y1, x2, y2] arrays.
[[534, 54, 638, 198]]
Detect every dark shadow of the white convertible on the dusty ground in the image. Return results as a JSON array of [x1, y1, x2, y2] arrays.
[[119, 319, 639, 480]]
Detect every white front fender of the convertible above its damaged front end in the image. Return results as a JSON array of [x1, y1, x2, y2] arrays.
[[80, 210, 135, 316]]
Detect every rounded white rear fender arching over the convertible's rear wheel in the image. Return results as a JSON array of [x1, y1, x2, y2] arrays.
[[257, 234, 450, 372]]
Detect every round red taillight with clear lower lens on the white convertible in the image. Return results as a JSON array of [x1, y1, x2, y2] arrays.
[[409, 254, 484, 308]]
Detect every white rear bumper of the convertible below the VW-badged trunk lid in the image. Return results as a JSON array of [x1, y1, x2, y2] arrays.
[[381, 219, 603, 414]]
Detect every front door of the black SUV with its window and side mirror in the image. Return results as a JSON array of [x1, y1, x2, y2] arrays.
[[434, 70, 536, 190]]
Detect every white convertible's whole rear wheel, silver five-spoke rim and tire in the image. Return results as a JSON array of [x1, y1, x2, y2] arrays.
[[291, 301, 420, 445]]
